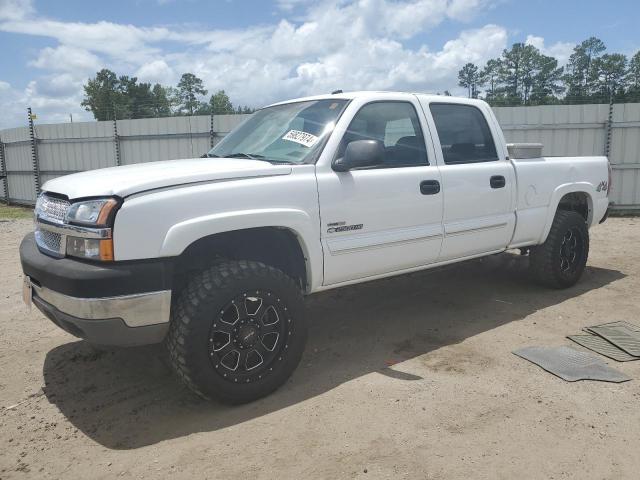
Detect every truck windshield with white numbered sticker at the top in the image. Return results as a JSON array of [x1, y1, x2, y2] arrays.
[[207, 99, 348, 164]]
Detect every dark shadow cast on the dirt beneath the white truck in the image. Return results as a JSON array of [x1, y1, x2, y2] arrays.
[[44, 254, 625, 449]]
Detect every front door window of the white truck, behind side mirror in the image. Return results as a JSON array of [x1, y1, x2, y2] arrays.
[[338, 102, 429, 168]]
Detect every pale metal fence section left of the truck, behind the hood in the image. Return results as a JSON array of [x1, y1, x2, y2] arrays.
[[0, 115, 247, 204]]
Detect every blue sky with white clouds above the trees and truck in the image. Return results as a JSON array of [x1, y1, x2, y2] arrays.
[[0, 0, 640, 128]]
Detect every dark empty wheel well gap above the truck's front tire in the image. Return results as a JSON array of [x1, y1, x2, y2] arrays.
[[172, 227, 307, 298]]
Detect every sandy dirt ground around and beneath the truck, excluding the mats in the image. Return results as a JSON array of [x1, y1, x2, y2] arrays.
[[0, 218, 640, 479]]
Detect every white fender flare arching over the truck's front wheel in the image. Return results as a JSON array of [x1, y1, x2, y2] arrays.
[[160, 208, 323, 290]]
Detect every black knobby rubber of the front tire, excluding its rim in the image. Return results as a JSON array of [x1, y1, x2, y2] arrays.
[[166, 260, 308, 404]]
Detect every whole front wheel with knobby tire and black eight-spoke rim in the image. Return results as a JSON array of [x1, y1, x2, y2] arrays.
[[167, 260, 307, 404]]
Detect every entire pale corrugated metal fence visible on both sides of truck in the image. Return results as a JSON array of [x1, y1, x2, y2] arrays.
[[0, 103, 640, 209]]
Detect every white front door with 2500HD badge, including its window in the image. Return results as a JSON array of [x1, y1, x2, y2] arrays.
[[317, 97, 443, 285]]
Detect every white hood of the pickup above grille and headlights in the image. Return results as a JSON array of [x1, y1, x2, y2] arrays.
[[42, 158, 291, 200]]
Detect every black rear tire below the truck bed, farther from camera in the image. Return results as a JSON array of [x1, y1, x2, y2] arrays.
[[529, 210, 589, 288]]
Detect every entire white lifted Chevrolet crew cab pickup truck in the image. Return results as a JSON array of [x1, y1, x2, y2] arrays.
[[20, 92, 610, 403]]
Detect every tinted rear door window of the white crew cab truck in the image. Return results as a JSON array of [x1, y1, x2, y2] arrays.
[[429, 103, 498, 165]]
